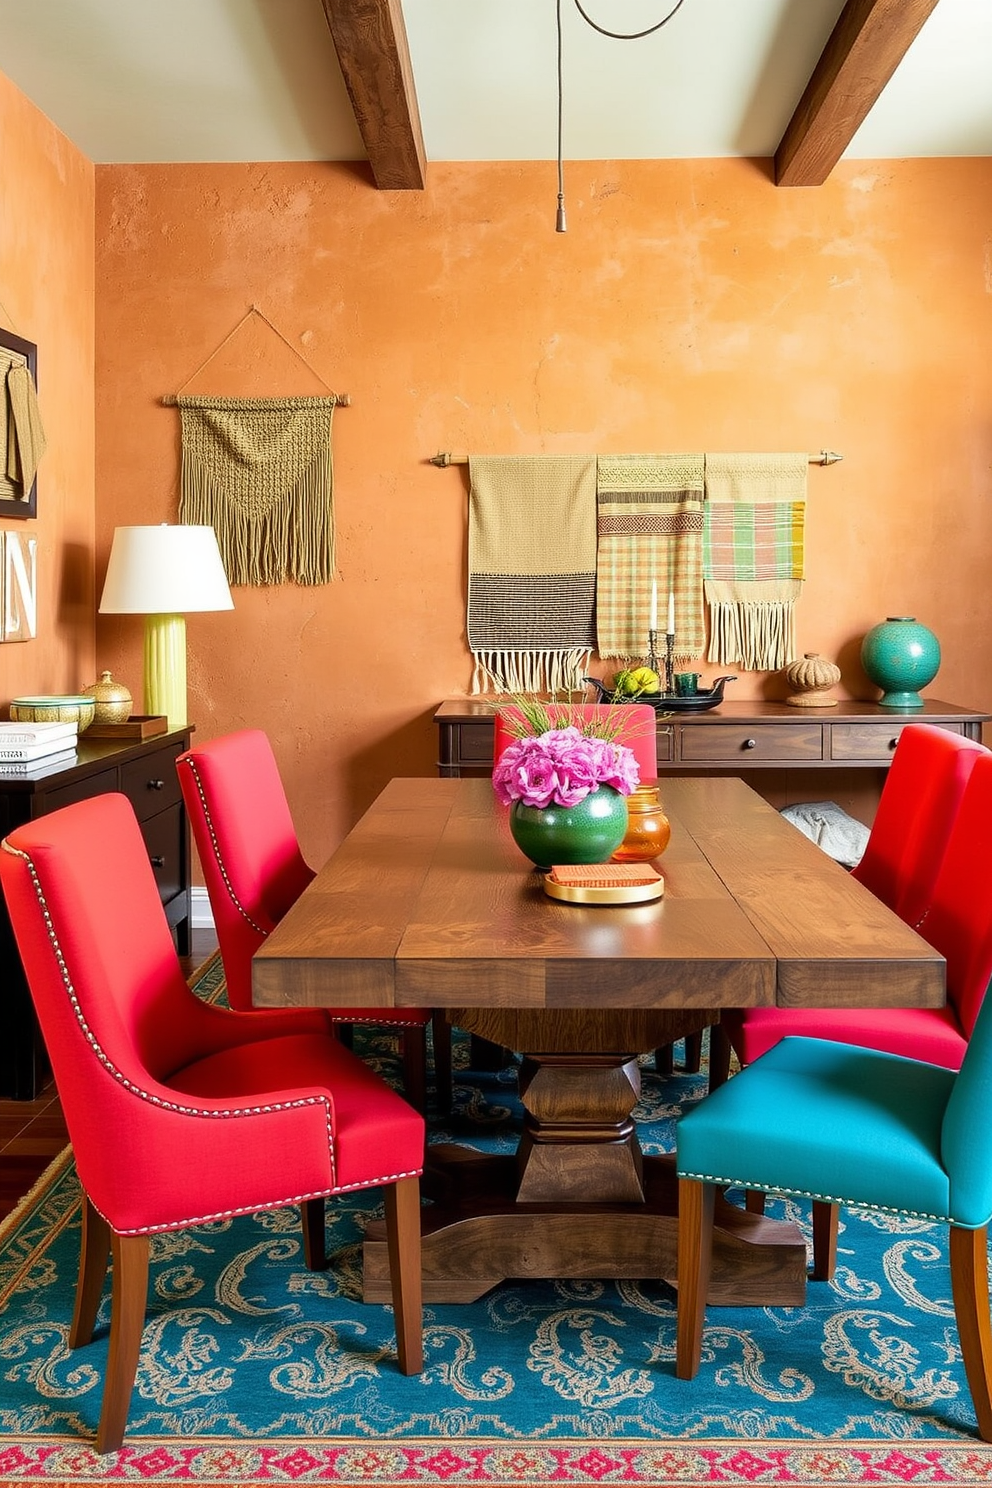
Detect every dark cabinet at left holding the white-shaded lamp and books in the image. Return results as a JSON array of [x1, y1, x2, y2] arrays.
[[0, 729, 192, 1100]]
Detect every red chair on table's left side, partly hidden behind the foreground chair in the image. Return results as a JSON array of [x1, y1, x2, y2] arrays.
[[175, 729, 451, 1110]]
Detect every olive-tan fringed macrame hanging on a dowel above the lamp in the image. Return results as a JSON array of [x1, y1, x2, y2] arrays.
[[164, 305, 351, 585]]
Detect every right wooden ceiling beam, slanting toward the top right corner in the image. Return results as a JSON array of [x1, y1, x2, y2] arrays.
[[775, 0, 937, 186]]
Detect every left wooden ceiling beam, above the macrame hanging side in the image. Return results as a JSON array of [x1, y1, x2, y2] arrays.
[[323, 0, 427, 190]]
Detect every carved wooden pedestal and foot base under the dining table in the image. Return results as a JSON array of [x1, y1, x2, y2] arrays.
[[363, 1031, 806, 1306]]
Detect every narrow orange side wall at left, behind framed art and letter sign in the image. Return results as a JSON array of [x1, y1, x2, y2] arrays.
[[0, 74, 95, 696]]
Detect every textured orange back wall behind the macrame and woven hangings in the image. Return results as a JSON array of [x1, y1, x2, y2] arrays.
[[97, 159, 992, 862]]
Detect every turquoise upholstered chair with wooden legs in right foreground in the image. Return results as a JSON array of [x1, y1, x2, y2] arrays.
[[675, 997, 992, 1442]]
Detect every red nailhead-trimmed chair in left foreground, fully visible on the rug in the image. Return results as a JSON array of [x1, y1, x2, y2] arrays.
[[0, 795, 424, 1452]]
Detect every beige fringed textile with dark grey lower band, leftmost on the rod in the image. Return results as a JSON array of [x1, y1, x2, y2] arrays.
[[468, 455, 596, 695]]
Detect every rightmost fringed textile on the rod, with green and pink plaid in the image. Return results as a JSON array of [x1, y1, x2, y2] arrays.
[[703, 454, 809, 671]]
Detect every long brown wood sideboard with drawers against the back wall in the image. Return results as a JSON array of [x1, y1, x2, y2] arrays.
[[434, 698, 992, 823]]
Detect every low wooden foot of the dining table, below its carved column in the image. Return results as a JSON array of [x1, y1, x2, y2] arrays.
[[363, 1144, 806, 1306]]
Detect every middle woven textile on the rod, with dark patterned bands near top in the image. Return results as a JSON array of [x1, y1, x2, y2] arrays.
[[596, 454, 705, 665]]
